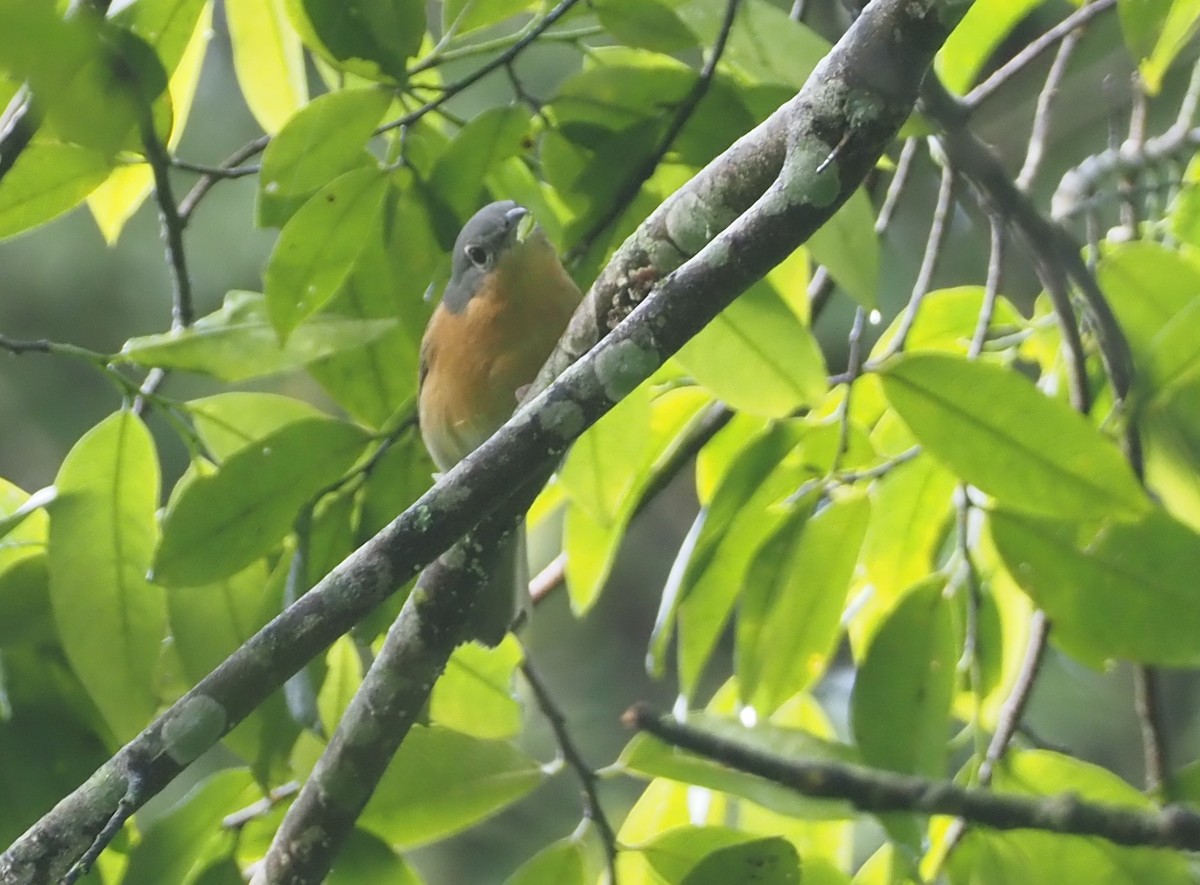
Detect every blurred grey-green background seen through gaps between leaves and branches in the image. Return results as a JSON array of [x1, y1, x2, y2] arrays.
[[0, 2, 1200, 881]]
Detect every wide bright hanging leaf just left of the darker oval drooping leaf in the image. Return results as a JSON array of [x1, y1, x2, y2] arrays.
[[736, 496, 871, 716]]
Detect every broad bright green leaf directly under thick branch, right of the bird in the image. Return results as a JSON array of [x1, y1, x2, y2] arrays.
[[676, 289, 827, 417]]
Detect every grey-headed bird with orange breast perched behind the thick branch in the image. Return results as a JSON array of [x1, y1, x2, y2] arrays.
[[418, 200, 582, 646]]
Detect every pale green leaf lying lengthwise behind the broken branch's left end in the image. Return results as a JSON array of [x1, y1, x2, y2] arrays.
[[617, 714, 854, 820]]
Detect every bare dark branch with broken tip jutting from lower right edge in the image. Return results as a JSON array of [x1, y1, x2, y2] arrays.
[[623, 704, 1200, 850]]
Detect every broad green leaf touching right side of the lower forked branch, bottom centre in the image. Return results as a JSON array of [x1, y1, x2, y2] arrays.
[[359, 726, 546, 848]]
